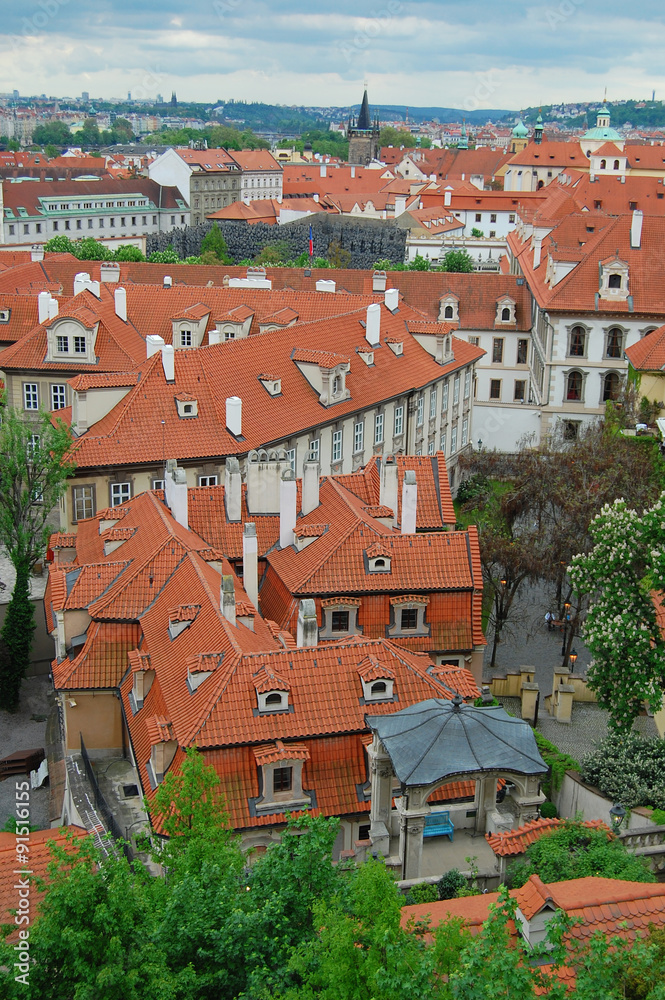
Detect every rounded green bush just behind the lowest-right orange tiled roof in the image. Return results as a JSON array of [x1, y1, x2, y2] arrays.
[[510, 822, 656, 887]]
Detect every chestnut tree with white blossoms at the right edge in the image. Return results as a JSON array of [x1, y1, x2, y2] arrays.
[[569, 493, 665, 733]]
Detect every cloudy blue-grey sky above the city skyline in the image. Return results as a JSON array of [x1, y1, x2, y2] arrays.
[[0, 0, 665, 110]]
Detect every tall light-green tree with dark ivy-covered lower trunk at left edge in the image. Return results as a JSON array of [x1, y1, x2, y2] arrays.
[[0, 406, 74, 712]]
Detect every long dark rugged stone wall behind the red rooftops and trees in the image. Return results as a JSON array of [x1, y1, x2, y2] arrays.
[[146, 215, 407, 269]]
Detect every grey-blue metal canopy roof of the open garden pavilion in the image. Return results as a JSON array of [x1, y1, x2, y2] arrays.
[[365, 696, 547, 785]]
